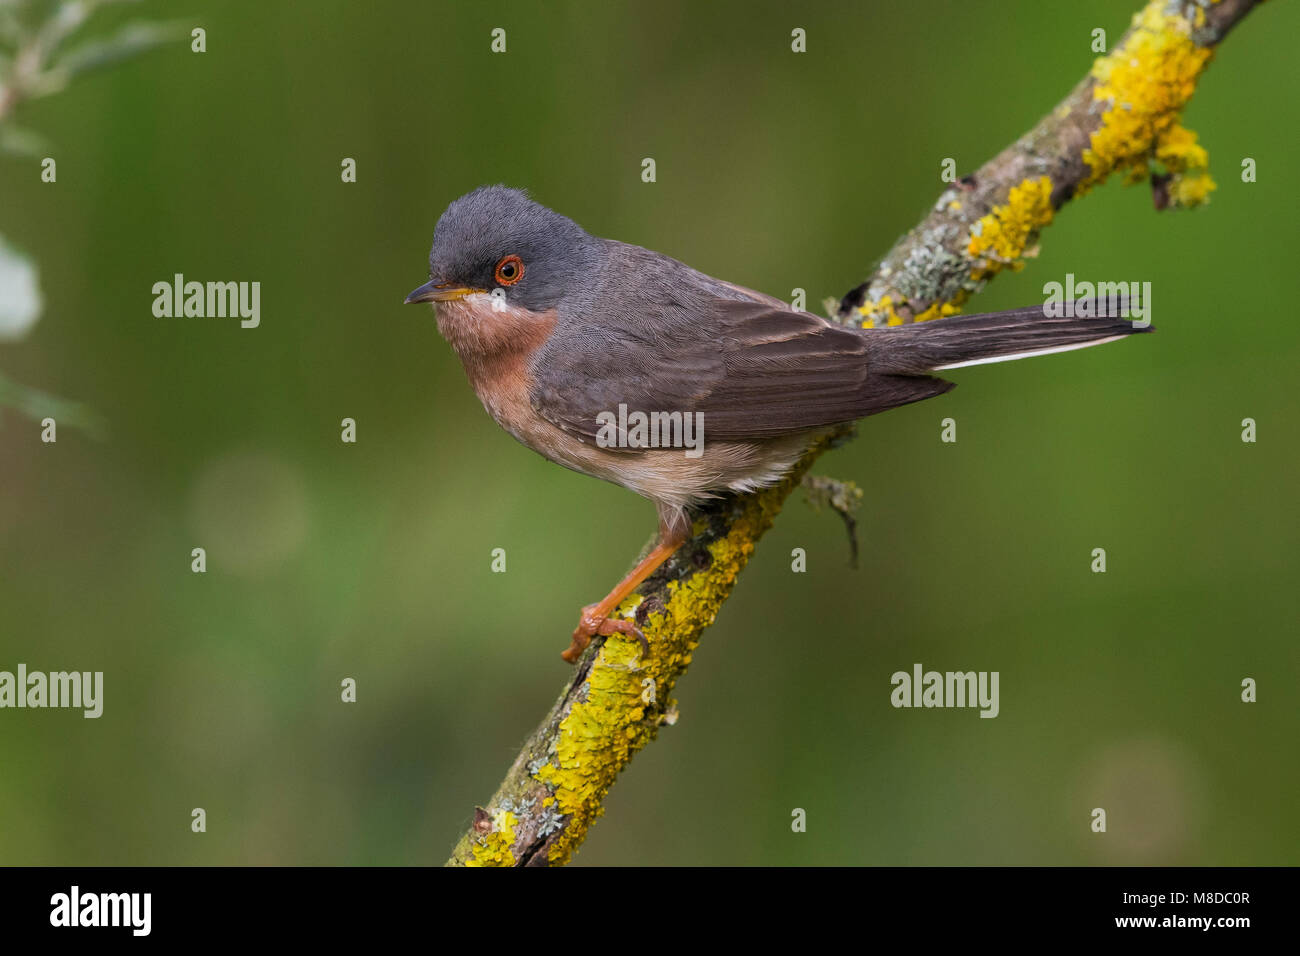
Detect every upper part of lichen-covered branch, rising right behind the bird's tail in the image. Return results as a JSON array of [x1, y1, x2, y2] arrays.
[[827, 0, 1258, 328]]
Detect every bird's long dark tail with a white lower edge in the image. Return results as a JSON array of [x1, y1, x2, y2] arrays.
[[872, 303, 1153, 375]]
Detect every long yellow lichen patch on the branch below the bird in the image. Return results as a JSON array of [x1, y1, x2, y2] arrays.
[[534, 473, 800, 864]]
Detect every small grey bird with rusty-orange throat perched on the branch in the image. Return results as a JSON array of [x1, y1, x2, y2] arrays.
[[406, 185, 1152, 663]]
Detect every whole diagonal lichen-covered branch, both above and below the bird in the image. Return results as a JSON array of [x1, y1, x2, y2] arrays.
[[449, 0, 1257, 866]]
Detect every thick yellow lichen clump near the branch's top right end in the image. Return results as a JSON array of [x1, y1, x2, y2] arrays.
[[1078, 0, 1214, 206]]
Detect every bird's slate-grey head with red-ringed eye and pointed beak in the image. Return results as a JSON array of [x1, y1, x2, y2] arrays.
[[406, 186, 602, 312]]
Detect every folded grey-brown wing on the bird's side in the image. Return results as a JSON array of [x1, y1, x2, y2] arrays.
[[530, 295, 952, 441]]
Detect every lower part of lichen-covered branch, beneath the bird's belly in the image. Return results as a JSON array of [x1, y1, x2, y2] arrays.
[[450, 444, 837, 866]]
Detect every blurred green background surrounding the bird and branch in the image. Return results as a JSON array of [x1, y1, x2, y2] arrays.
[[0, 0, 1300, 865]]
